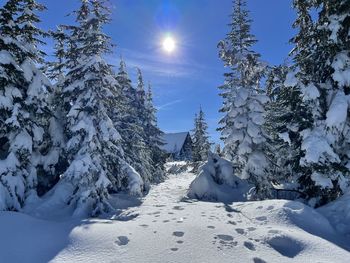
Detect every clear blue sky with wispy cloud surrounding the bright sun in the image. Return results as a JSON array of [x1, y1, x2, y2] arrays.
[[40, 0, 295, 142]]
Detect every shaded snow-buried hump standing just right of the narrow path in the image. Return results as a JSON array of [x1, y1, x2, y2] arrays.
[[187, 153, 249, 202]]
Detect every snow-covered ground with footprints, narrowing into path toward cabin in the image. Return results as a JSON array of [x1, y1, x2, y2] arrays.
[[0, 167, 350, 263]]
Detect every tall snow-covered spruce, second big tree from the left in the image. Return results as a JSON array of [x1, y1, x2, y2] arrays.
[[55, 0, 141, 215]]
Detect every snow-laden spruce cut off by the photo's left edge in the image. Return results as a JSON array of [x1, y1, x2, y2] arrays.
[[0, 0, 57, 210]]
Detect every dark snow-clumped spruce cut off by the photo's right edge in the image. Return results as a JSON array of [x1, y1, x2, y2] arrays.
[[290, 0, 350, 206]]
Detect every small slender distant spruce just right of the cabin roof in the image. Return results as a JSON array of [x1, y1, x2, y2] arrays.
[[192, 107, 211, 162]]
